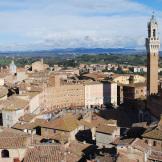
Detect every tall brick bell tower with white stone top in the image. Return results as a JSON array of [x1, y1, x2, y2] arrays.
[[146, 15, 160, 96]]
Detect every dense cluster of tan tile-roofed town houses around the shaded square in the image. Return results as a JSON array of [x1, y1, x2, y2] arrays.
[[0, 60, 161, 162]]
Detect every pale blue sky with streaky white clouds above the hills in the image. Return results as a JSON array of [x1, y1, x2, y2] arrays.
[[0, 0, 162, 51]]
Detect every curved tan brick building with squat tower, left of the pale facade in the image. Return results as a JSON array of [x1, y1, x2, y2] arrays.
[[43, 75, 84, 109]]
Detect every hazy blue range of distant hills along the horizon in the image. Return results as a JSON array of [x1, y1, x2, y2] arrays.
[[0, 48, 162, 57]]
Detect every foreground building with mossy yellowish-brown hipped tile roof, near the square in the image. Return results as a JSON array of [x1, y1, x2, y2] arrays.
[[37, 114, 84, 142]]
